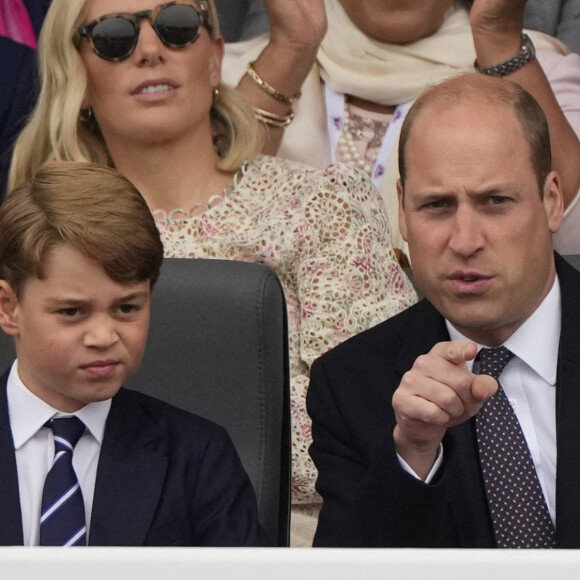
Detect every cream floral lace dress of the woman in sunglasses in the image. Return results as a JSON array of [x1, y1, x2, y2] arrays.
[[155, 156, 416, 505]]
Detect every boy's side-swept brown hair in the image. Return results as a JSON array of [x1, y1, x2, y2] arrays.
[[0, 161, 163, 296]]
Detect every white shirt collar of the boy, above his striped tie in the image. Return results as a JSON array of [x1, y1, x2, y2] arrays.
[[6, 360, 111, 449]]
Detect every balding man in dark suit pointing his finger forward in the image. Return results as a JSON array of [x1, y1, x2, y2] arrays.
[[308, 75, 580, 547]]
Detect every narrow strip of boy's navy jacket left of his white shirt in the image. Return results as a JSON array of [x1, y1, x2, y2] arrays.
[[0, 371, 23, 546]]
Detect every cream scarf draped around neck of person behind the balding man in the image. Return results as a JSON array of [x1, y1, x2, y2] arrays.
[[318, 0, 568, 105]]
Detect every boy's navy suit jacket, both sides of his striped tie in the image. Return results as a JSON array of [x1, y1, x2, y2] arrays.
[[0, 373, 263, 546]]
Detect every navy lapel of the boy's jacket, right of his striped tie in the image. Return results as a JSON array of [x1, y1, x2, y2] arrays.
[[89, 389, 168, 546]]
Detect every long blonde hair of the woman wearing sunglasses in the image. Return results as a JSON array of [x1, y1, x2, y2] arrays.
[[8, 0, 262, 189]]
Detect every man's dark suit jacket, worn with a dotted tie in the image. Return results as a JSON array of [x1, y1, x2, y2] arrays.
[[308, 256, 580, 548]]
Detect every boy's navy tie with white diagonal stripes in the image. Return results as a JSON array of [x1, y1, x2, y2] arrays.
[[40, 417, 87, 546]]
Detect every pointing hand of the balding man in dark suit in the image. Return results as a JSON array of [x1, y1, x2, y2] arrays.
[[393, 340, 498, 479]]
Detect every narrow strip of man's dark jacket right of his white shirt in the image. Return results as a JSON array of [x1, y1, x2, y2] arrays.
[[556, 256, 580, 548]]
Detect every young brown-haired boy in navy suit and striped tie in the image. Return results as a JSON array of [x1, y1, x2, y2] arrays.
[[0, 162, 261, 546]]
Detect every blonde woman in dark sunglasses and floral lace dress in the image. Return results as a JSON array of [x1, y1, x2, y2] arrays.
[[10, 0, 415, 544]]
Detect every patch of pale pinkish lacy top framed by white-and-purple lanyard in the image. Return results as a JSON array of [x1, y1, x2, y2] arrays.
[[337, 103, 390, 175]]
